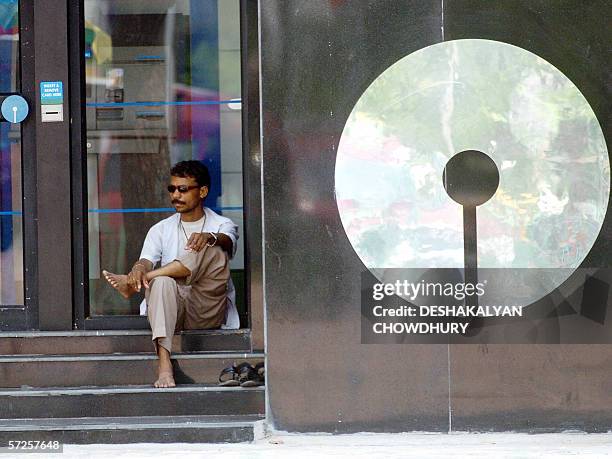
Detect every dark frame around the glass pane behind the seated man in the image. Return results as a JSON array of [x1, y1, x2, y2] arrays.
[[68, 0, 264, 342]]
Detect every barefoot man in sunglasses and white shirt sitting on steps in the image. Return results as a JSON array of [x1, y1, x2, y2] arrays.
[[103, 161, 240, 387]]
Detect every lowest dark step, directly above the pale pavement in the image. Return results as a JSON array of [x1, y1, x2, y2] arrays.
[[0, 415, 263, 444]]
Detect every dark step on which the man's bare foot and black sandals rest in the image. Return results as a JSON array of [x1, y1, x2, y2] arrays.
[[0, 385, 265, 424]]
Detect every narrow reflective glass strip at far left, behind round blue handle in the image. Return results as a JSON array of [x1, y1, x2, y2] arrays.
[[0, 0, 24, 306]]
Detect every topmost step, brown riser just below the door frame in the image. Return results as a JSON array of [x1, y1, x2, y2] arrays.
[[0, 329, 251, 355]]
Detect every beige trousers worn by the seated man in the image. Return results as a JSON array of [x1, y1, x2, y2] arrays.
[[145, 246, 229, 352]]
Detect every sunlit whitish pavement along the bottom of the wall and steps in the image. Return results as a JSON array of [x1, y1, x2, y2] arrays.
[[31, 433, 612, 459]]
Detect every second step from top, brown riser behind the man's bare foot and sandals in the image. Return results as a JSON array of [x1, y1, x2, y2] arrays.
[[0, 352, 264, 388]]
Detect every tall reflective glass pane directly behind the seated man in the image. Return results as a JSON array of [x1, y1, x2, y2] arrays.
[[84, 0, 243, 315]]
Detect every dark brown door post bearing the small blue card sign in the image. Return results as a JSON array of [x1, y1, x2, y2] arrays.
[[0, 0, 73, 331]]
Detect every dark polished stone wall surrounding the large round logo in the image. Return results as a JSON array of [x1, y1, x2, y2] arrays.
[[260, 0, 612, 432]]
